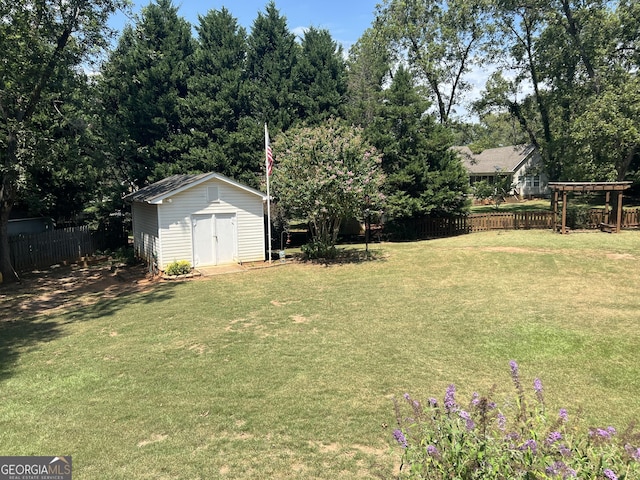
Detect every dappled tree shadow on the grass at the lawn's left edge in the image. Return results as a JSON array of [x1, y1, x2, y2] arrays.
[[0, 283, 176, 382]]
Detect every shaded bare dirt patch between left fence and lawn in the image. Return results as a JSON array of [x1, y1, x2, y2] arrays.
[[0, 263, 160, 322]]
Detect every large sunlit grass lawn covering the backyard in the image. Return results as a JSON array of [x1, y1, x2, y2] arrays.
[[0, 231, 640, 480]]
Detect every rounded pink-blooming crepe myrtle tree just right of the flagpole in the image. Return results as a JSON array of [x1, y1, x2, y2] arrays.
[[272, 119, 384, 256]]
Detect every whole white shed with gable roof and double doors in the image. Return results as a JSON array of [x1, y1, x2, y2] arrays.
[[124, 173, 267, 270]]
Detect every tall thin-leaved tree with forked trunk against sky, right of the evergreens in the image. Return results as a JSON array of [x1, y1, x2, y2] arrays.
[[374, 0, 491, 124]]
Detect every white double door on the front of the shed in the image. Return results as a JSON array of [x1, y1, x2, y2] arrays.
[[191, 213, 237, 267]]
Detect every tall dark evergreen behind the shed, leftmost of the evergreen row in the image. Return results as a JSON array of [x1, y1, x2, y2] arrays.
[[100, 0, 194, 188]]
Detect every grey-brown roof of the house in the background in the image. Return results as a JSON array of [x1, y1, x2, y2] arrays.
[[452, 145, 535, 175]]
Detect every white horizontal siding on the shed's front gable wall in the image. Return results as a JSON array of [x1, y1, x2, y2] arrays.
[[158, 179, 265, 270]]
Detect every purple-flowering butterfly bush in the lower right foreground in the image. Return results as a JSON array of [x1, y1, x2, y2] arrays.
[[393, 360, 640, 480]]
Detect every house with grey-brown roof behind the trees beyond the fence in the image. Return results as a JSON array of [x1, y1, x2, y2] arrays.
[[453, 145, 549, 198]]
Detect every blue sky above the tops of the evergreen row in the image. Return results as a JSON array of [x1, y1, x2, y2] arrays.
[[109, 0, 381, 52]]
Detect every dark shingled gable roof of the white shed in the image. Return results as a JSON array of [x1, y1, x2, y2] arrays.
[[124, 172, 267, 205]]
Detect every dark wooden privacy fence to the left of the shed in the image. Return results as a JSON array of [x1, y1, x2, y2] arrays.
[[9, 226, 94, 272]]
